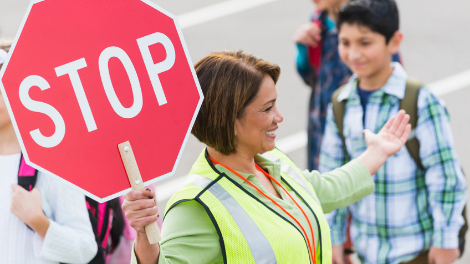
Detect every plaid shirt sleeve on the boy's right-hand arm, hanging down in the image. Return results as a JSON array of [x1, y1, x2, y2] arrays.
[[416, 88, 467, 248]]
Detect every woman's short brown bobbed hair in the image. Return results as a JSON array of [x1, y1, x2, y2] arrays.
[[191, 50, 281, 155]]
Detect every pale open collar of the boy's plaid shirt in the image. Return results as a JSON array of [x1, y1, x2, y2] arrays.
[[337, 62, 408, 102]]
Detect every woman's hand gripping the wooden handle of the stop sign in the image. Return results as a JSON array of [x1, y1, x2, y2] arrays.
[[122, 187, 158, 233]]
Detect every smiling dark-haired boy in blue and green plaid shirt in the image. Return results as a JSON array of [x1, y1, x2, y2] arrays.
[[320, 0, 466, 264]]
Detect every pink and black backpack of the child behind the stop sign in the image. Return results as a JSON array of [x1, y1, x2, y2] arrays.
[[18, 154, 125, 264]]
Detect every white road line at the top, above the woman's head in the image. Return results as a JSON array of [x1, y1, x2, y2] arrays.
[[177, 0, 278, 29]]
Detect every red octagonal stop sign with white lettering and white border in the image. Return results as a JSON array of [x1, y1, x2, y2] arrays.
[[0, 0, 203, 202]]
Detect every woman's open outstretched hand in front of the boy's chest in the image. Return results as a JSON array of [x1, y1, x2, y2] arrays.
[[364, 110, 411, 158]]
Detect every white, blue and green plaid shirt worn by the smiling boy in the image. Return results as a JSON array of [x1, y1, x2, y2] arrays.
[[319, 63, 466, 263]]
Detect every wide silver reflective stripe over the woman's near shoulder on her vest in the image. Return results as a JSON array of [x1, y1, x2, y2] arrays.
[[186, 174, 277, 264]]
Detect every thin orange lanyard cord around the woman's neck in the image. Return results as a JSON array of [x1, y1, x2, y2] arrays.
[[209, 157, 317, 263]]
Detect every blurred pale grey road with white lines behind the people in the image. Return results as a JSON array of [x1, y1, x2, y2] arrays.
[[0, 0, 470, 264]]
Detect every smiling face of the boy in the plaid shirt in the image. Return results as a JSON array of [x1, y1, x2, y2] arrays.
[[338, 23, 402, 78]]
